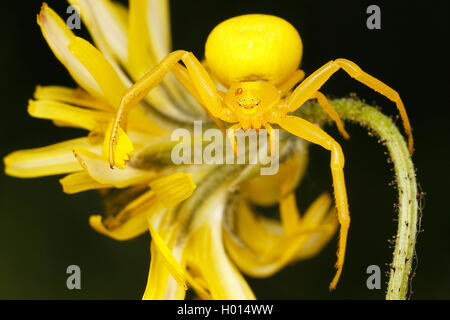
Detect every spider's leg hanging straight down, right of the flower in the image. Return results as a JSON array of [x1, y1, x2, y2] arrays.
[[276, 116, 350, 289]]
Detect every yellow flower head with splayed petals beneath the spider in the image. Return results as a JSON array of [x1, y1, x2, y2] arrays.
[[4, 0, 337, 299]]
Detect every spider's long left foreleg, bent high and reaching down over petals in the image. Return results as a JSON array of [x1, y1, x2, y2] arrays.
[[109, 50, 231, 167]]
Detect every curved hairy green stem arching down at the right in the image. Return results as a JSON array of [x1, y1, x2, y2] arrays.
[[300, 99, 418, 300]]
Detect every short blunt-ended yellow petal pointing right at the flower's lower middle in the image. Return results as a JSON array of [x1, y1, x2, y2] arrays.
[[149, 172, 196, 208]]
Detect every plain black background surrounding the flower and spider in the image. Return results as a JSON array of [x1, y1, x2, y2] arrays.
[[0, 0, 450, 299]]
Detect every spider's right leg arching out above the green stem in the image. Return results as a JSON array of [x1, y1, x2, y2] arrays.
[[287, 59, 414, 152]]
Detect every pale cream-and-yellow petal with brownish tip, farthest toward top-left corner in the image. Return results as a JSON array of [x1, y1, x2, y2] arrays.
[[37, 3, 102, 96]]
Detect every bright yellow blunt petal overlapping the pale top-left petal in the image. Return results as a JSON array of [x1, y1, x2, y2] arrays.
[[69, 37, 125, 108]]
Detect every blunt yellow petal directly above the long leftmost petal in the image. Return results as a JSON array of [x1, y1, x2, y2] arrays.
[[28, 100, 111, 130]]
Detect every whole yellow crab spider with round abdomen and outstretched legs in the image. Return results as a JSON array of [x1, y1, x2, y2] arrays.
[[109, 14, 413, 289]]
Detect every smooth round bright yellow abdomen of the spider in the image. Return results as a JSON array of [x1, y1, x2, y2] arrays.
[[205, 14, 302, 86]]
